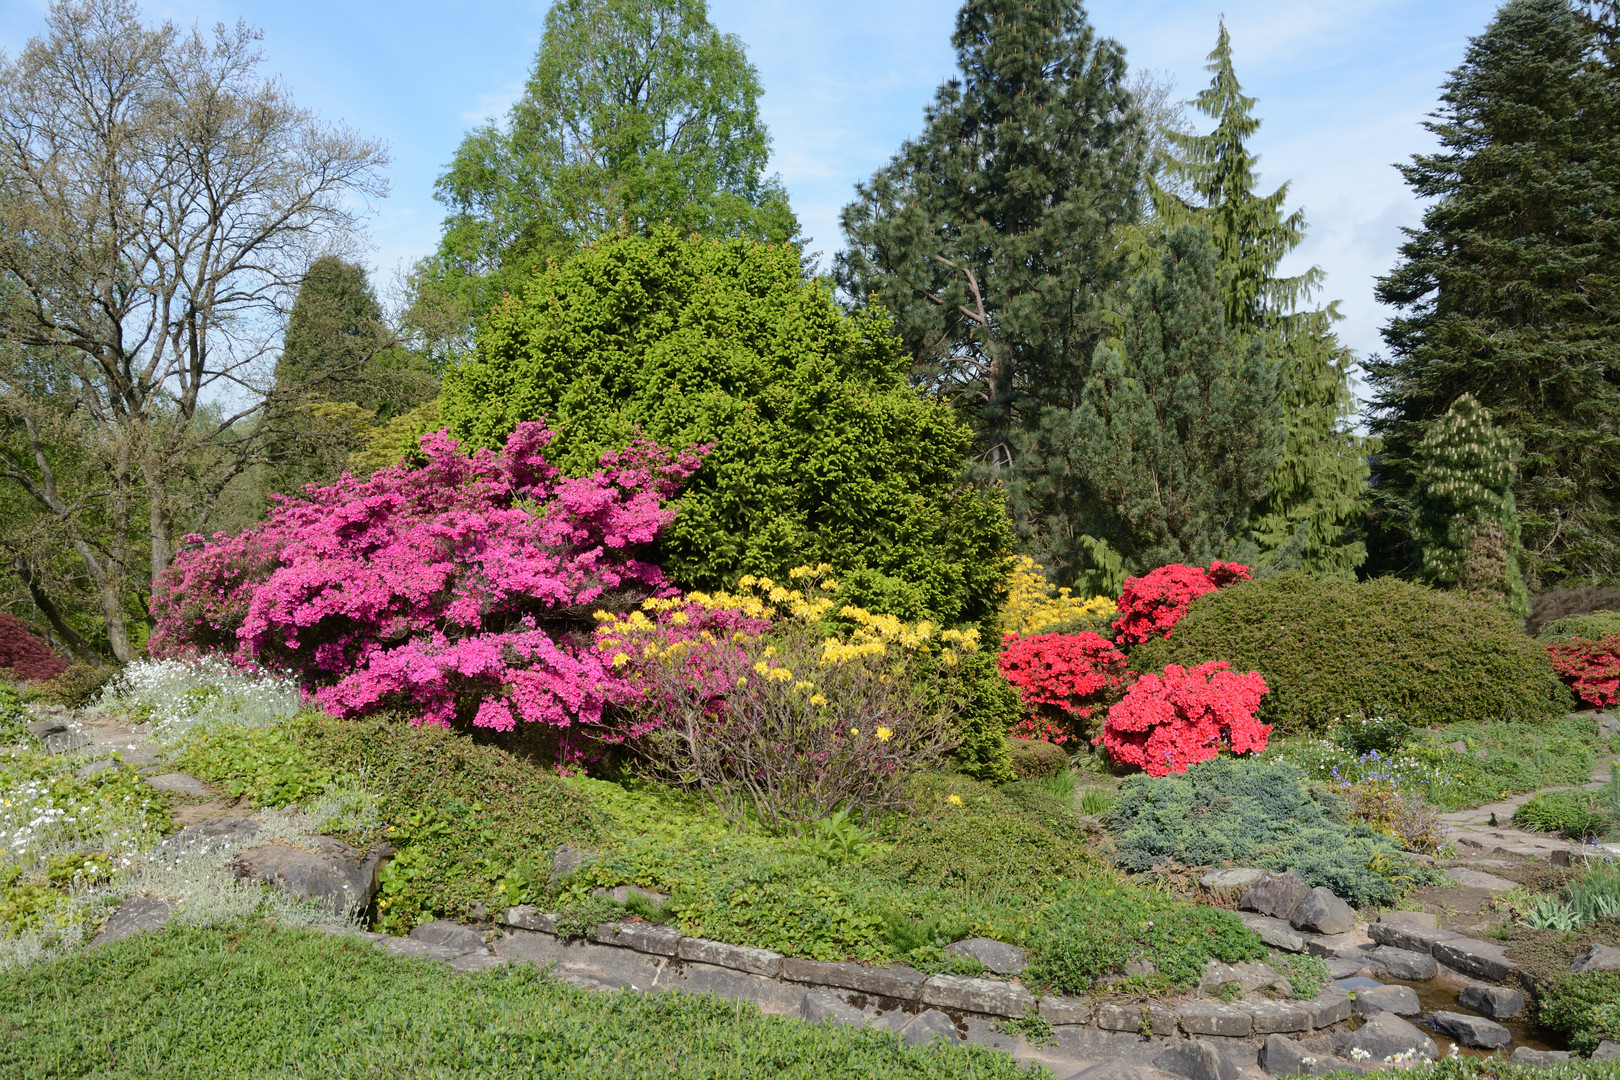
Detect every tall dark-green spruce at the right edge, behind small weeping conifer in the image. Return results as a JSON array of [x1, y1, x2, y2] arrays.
[[1367, 0, 1620, 586]]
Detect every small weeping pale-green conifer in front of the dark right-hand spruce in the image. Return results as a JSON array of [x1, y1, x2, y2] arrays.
[[1411, 393, 1529, 615]]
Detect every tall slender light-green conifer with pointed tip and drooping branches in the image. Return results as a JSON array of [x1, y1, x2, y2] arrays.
[[1152, 21, 1367, 575]]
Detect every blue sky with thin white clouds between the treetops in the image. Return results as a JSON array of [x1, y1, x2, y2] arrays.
[[0, 0, 1497, 369]]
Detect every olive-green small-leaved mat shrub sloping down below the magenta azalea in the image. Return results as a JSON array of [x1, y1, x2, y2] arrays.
[[287, 716, 604, 933]]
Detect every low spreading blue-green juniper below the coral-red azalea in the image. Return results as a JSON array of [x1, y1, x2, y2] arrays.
[[1110, 758, 1434, 907]]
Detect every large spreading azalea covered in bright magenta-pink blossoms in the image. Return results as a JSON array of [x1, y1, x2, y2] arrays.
[[151, 423, 706, 744]]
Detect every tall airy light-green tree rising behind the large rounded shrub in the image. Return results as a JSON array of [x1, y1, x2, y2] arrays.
[[416, 0, 797, 359]]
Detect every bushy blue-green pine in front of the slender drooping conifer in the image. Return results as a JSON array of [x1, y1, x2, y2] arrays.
[[1040, 225, 1285, 567]]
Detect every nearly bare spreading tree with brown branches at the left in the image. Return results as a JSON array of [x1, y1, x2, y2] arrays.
[[0, 0, 387, 661]]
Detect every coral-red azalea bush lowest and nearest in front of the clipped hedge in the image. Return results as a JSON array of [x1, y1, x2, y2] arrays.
[[1094, 661, 1272, 776]]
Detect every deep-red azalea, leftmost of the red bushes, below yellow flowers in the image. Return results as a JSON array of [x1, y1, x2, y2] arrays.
[[996, 630, 1131, 743]]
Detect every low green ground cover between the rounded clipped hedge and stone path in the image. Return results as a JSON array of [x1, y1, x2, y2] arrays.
[[1265, 717, 1604, 811]]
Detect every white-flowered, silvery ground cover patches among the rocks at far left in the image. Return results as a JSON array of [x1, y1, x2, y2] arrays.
[[0, 661, 365, 970]]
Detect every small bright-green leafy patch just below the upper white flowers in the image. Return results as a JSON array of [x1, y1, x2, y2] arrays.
[[175, 724, 334, 806]]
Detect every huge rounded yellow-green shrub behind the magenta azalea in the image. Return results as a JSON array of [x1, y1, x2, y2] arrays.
[[442, 228, 1011, 628]]
